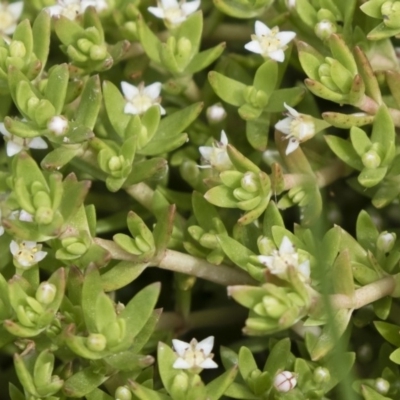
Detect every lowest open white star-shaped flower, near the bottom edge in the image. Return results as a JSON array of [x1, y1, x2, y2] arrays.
[[172, 336, 218, 373]]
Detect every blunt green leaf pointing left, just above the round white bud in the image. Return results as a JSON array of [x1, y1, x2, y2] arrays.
[[208, 71, 247, 107]]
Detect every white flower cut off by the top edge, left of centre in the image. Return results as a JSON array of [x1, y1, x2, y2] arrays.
[[148, 0, 200, 26]]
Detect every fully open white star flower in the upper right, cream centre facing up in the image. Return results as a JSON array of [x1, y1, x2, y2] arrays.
[[244, 21, 296, 62]]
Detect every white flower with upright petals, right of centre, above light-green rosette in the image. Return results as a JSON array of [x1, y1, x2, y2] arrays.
[[257, 236, 310, 281]]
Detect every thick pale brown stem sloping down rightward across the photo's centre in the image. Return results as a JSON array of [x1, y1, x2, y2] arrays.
[[94, 238, 257, 286]]
